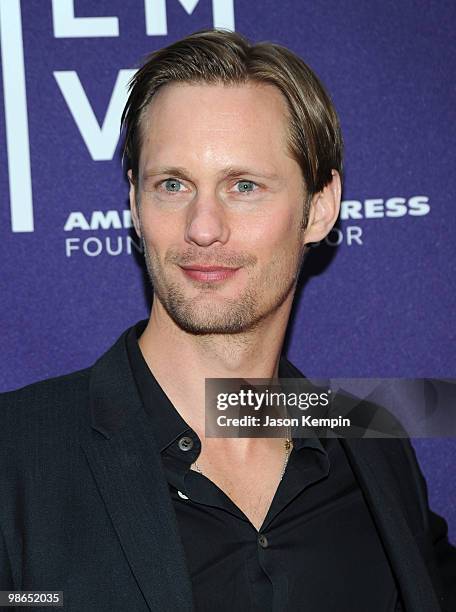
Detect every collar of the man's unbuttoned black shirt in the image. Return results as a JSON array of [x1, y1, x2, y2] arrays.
[[126, 319, 326, 454]]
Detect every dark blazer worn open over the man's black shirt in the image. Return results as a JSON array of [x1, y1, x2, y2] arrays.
[[0, 322, 456, 612]]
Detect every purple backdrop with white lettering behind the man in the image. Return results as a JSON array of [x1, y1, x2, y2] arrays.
[[0, 0, 456, 540]]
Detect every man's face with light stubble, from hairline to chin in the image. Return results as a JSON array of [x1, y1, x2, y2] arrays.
[[130, 84, 312, 334]]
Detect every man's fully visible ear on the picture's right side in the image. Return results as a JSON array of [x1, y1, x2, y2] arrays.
[[303, 170, 342, 244]]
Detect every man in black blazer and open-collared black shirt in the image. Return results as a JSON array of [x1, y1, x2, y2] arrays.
[[0, 30, 456, 612]]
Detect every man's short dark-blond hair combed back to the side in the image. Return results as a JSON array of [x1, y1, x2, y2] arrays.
[[122, 28, 343, 218]]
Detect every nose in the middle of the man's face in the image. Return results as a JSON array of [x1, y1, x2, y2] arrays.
[[185, 193, 230, 247]]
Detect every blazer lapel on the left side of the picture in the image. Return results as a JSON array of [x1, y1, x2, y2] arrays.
[[80, 334, 193, 611]]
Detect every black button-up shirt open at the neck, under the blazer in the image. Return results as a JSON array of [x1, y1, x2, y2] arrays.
[[127, 321, 402, 612]]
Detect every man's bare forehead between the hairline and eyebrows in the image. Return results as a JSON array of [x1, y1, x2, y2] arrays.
[[140, 83, 288, 172]]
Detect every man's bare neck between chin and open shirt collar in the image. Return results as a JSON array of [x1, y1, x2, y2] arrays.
[[139, 296, 292, 437]]
